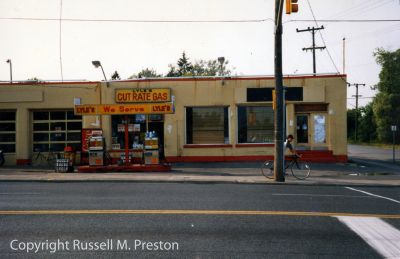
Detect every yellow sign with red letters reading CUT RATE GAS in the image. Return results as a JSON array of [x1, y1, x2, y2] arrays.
[[115, 88, 171, 103]]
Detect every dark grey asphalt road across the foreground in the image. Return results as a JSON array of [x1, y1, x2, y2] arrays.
[[0, 182, 400, 258]]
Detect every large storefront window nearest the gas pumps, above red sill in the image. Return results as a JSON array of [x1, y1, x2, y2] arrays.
[[186, 107, 229, 144]]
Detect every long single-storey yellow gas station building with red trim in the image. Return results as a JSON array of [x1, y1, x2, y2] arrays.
[[0, 74, 347, 165]]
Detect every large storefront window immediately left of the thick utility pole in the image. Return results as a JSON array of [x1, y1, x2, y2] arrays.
[[238, 106, 274, 143]]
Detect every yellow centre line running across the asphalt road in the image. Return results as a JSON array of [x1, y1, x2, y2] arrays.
[[0, 210, 400, 219]]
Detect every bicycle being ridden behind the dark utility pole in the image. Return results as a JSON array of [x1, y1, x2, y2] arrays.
[[261, 156, 311, 180]]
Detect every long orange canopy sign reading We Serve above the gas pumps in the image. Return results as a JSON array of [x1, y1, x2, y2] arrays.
[[74, 103, 174, 115]]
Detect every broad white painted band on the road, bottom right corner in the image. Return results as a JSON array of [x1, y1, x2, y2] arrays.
[[336, 216, 400, 258]]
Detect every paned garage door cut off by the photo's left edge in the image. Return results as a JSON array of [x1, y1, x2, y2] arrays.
[[0, 111, 16, 153]]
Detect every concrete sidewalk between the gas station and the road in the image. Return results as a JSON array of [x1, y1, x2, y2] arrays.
[[0, 162, 400, 186]]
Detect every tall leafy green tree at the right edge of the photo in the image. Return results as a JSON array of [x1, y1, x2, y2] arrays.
[[373, 48, 400, 143]]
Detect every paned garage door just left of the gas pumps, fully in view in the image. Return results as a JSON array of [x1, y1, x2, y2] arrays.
[[32, 110, 82, 152]]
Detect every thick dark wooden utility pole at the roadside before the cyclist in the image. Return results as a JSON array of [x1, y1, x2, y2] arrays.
[[274, 0, 288, 182]]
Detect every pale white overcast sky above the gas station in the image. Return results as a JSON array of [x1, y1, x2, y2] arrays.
[[0, 0, 400, 108]]
